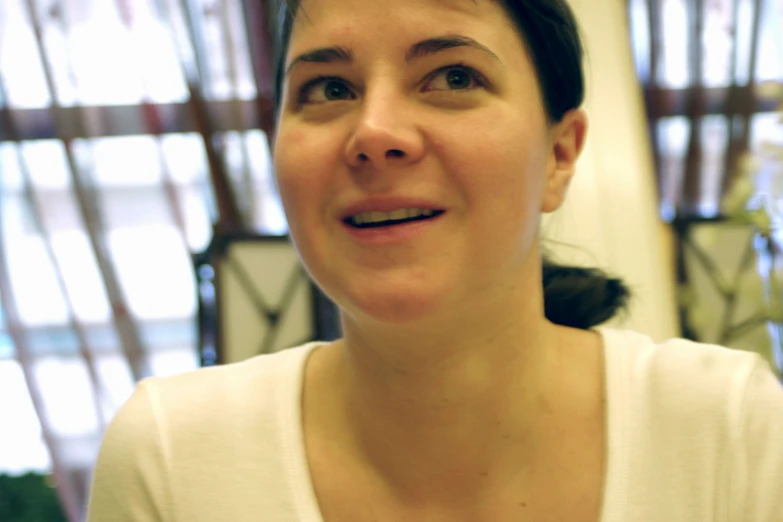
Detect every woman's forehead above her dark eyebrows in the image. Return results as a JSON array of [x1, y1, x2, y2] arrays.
[[289, 0, 524, 51]]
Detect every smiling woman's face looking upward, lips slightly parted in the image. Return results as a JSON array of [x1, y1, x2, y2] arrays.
[[274, 0, 567, 324]]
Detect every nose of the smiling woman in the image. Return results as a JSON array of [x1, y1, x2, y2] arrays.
[[345, 90, 424, 168]]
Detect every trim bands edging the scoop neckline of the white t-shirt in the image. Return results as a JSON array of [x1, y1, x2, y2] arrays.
[[281, 327, 628, 522]]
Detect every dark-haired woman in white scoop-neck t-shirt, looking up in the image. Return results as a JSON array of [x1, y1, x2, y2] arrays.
[[90, 0, 783, 522]]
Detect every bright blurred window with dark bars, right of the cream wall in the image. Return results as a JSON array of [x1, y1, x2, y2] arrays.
[[629, 0, 783, 220]]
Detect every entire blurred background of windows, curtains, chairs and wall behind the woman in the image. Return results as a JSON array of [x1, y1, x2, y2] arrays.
[[0, 0, 783, 522]]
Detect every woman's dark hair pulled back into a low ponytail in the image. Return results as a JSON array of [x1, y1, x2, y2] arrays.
[[269, 0, 630, 329]]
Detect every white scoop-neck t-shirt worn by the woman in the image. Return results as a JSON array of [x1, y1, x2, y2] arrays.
[[88, 328, 783, 522]]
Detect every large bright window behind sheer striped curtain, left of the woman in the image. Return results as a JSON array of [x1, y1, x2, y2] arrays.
[[0, 0, 287, 516]]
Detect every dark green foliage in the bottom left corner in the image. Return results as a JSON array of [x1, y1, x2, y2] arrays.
[[0, 473, 66, 522]]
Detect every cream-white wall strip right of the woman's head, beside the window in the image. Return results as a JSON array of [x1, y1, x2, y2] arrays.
[[543, 0, 679, 340]]
